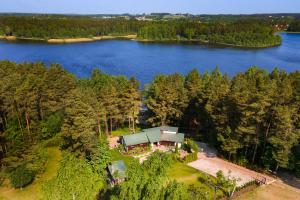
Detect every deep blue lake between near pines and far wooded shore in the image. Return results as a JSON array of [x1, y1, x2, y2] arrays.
[[0, 33, 300, 84]]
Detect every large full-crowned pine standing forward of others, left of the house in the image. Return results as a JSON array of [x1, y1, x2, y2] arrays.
[[61, 88, 98, 156]]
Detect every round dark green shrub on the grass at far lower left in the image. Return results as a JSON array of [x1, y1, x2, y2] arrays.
[[9, 165, 35, 188]]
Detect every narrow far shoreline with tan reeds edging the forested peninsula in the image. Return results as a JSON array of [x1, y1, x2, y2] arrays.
[[0, 33, 284, 49]]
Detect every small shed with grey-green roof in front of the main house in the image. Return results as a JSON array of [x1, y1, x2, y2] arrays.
[[108, 160, 126, 184]]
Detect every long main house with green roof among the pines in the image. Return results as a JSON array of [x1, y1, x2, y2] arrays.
[[122, 126, 184, 151]]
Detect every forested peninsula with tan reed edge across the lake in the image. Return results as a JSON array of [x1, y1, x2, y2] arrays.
[[0, 16, 281, 48]]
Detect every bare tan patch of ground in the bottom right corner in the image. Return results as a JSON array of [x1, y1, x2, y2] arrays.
[[237, 181, 300, 200]]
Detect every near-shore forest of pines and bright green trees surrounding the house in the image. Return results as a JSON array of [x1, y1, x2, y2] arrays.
[[0, 61, 300, 199]]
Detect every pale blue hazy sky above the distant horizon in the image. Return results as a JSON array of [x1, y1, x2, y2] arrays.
[[0, 0, 300, 14]]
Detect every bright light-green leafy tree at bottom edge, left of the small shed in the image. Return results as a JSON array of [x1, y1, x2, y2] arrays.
[[42, 153, 105, 200]]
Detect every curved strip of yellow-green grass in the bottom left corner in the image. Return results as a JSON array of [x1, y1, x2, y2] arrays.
[[0, 147, 61, 200]]
